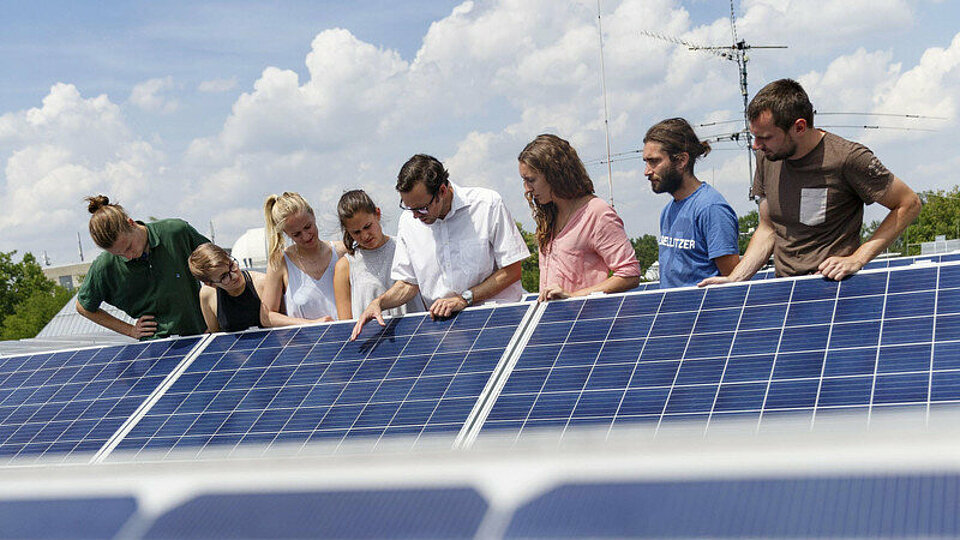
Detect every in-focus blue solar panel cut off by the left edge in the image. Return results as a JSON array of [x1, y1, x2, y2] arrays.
[[0, 337, 200, 463]]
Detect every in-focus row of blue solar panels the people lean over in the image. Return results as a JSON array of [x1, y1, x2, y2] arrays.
[[0, 254, 960, 461]]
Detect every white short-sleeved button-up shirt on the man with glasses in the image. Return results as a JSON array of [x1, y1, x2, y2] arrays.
[[390, 183, 530, 307]]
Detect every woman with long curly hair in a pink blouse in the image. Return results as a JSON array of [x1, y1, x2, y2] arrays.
[[518, 134, 640, 301]]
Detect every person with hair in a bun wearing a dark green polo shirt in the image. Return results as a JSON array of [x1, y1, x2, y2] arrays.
[[77, 195, 209, 340]]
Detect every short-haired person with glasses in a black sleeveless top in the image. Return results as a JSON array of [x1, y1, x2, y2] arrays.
[[187, 242, 320, 333]]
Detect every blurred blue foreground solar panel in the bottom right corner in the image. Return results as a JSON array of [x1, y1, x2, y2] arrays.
[[504, 475, 960, 538]]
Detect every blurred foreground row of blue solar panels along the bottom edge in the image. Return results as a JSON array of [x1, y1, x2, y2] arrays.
[[7, 473, 960, 539]]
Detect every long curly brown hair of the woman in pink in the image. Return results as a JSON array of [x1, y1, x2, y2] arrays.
[[517, 133, 593, 253]]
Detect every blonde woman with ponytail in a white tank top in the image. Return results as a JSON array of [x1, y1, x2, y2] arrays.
[[262, 192, 345, 324]]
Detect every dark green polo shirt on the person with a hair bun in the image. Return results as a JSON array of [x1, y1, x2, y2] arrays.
[[77, 219, 209, 338]]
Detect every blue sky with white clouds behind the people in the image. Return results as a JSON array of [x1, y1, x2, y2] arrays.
[[0, 0, 960, 264]]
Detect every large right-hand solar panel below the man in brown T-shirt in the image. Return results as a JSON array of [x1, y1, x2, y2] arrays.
[[482, 264, 960, 438]]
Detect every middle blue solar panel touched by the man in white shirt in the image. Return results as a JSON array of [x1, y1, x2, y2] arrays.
[[117, 304, 531, 459]]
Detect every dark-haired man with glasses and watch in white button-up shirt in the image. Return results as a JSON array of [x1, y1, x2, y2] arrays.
[[351, 154, 530, 339]]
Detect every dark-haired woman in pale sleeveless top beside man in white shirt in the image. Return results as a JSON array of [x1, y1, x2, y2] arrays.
[[333, 189, 423, 320]]
